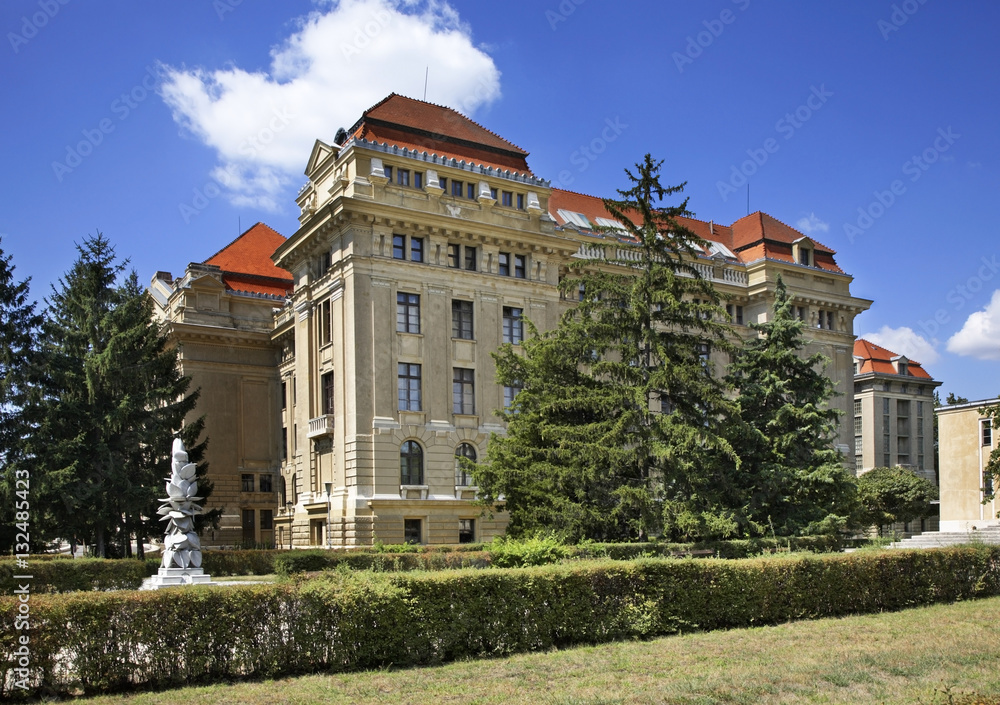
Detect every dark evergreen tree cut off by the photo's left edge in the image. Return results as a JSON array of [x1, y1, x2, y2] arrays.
[[0, 240, 41, 553]]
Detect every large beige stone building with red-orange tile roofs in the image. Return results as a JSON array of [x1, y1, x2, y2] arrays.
[[150, 94, 871, 547]]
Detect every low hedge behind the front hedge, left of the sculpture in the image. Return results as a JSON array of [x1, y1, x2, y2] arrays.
[[0, 558, 148, 595]]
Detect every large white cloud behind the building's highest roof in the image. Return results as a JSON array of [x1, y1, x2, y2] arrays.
[[161, 0, 500, 210]]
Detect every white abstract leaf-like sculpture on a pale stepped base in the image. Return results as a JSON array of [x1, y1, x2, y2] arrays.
[[143, 438, 212, 590]]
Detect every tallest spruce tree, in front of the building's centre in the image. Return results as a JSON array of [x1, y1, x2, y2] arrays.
[[474, 155, 739, 540]]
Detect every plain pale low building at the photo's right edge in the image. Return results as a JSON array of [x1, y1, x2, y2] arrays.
[[937, 399, 1000, 531]]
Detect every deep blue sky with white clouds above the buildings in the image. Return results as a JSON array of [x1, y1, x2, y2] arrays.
[[0, 0, 1000, 399]]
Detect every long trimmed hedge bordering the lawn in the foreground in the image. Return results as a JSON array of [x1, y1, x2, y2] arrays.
[[0, 547, 1000, 697]]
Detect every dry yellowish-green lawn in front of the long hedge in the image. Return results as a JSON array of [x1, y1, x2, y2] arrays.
[[80, 598, 1000, 705]]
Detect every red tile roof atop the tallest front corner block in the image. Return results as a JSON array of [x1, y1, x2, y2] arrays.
[[350, 93, 531, 174]]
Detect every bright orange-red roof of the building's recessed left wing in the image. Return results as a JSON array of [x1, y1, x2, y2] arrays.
[[204, 223, 292, 296]]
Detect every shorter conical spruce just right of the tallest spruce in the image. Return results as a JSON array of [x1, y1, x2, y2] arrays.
[[726, 275, 854, 535]]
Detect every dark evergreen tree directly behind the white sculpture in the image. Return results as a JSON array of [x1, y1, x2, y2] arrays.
[[31, 234, 204, 556]]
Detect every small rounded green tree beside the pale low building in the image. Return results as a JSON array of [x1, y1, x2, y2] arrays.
[[857, 465, 938, 534]]
